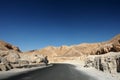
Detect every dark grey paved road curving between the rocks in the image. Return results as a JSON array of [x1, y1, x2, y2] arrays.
[[5, 64, 95, 80]]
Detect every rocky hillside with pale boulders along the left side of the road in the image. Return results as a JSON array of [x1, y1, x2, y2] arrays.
[[0, 41, 47, 71]]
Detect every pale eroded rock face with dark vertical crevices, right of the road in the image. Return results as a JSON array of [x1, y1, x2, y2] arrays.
[[85, 52, 120, 73]]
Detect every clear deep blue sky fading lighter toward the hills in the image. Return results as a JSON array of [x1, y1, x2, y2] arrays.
[[0, 0, 120, 51]]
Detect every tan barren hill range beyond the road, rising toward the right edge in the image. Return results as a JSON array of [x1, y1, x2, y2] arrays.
[[25, 34, 120, 62]]
